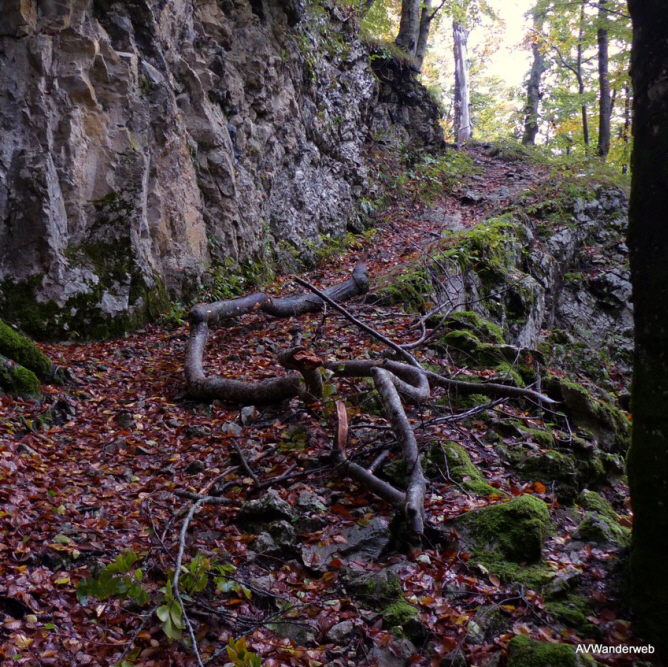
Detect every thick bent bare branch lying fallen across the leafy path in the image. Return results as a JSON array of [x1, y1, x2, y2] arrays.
[[185, 264, 555, 535]]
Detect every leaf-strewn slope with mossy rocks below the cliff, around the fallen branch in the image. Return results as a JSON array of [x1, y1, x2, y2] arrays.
[[0, 145, 651, 667]]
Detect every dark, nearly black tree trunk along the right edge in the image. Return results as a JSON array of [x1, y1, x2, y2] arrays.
[[627, 0, 668, 656]]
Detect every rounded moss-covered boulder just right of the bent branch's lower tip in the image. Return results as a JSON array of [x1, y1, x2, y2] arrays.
[[454, 495, 551, 564]]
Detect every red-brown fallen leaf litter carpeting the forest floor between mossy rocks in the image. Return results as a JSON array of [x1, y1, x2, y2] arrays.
[[0, 148, 648, 667]]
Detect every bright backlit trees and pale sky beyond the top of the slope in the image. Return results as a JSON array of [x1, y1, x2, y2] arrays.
[[360, 0, 632, 164]]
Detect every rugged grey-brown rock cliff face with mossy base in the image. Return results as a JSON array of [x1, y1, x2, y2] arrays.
[[0, 0, 442, 337]]
